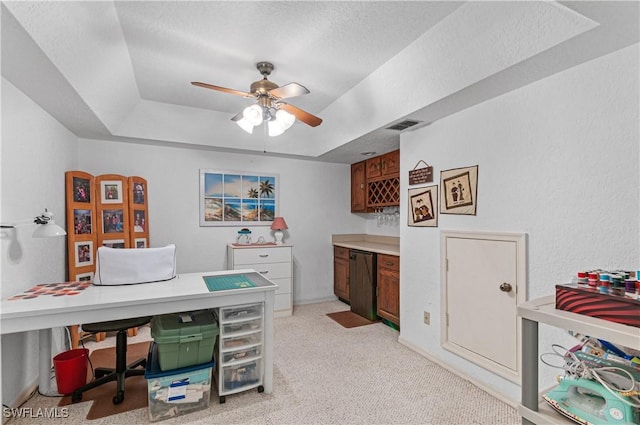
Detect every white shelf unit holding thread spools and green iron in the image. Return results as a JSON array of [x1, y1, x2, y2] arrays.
[[518, 295, 640, 425]]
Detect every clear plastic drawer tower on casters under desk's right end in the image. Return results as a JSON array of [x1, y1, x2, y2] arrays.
[[214, 303, 264, 403]]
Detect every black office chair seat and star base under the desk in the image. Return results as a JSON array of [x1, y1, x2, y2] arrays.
[[71, 316, 151, 404]]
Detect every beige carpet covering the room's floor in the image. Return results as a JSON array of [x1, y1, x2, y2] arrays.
[[15, 301, 521, 425]]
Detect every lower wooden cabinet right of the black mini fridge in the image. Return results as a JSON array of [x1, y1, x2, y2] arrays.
[[378, 254, 400, 326]]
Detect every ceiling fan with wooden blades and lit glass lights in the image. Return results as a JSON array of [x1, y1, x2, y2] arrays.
[[191, 62, 322, 136]]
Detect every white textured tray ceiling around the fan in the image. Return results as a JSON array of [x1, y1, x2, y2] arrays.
[[2, 1, 638, 163]]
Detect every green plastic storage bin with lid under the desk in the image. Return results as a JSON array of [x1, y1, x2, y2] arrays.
[[151, 310, 218, 371]]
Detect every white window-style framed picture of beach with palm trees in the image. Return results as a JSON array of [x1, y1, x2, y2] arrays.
[[199, 169, 280, 227]]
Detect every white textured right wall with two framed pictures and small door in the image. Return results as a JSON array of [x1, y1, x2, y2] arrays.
[[400, 44, 640, 400]]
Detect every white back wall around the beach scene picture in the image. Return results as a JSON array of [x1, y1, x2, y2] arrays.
[[79, 139, 366, 304]]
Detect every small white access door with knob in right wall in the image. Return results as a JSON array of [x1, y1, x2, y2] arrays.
[[443, 230, 526, 381]]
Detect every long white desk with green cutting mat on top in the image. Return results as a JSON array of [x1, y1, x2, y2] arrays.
[[0, 270, 278, 394]]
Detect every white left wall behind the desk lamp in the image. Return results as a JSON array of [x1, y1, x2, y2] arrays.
[[0, 78, 78, 404]]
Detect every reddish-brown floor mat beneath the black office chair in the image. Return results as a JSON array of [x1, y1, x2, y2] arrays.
[[58, 342, 149, 420]]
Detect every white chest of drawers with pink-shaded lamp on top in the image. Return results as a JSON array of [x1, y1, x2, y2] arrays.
[[227, 244, 293, 317]]
